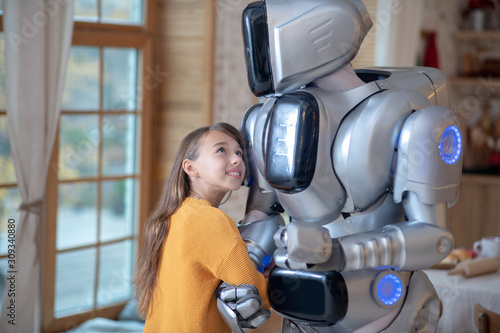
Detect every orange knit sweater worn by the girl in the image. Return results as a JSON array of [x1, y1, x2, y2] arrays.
[[144, 198, 269, 333]]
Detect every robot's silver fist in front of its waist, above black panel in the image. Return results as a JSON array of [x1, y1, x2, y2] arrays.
[[274, 221, 345, 271]]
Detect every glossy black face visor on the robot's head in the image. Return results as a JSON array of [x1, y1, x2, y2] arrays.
[[242, 1, 274, 97]]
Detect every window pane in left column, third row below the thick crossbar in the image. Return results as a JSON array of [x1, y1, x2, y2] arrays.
[[56, 182, 97, 250]]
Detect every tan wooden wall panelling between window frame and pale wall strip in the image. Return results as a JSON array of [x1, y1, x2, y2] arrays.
[[151, 0, 215, 202]]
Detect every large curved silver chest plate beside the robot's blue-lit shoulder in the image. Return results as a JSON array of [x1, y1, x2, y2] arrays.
[[332, 90, 430, 213]]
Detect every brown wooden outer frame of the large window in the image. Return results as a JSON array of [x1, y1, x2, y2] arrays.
[[41, 0, 156, 333]]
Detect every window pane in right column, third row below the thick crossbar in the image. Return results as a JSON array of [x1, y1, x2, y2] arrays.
[[100, 179, 136, 242]]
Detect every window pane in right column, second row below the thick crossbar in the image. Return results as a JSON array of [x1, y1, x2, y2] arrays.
[[102, 115, 138, 176]]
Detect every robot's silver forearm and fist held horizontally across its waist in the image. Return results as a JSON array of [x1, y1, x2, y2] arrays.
[[275, 222, 454, 271]]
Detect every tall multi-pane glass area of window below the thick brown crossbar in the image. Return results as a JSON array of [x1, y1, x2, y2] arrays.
[[51, 46, 141, 317]]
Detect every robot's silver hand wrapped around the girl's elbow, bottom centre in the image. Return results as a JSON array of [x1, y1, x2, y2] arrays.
[[215, 282, 271, 333]]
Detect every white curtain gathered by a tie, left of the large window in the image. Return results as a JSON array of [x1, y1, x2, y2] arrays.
[[0, 0, 74, 333]]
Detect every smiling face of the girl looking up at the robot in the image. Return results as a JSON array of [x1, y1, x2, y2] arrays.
[[188, 131, 245, 206]]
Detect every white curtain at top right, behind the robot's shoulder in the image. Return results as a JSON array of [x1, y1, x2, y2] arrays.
[[374, 0, 424, 66]]
